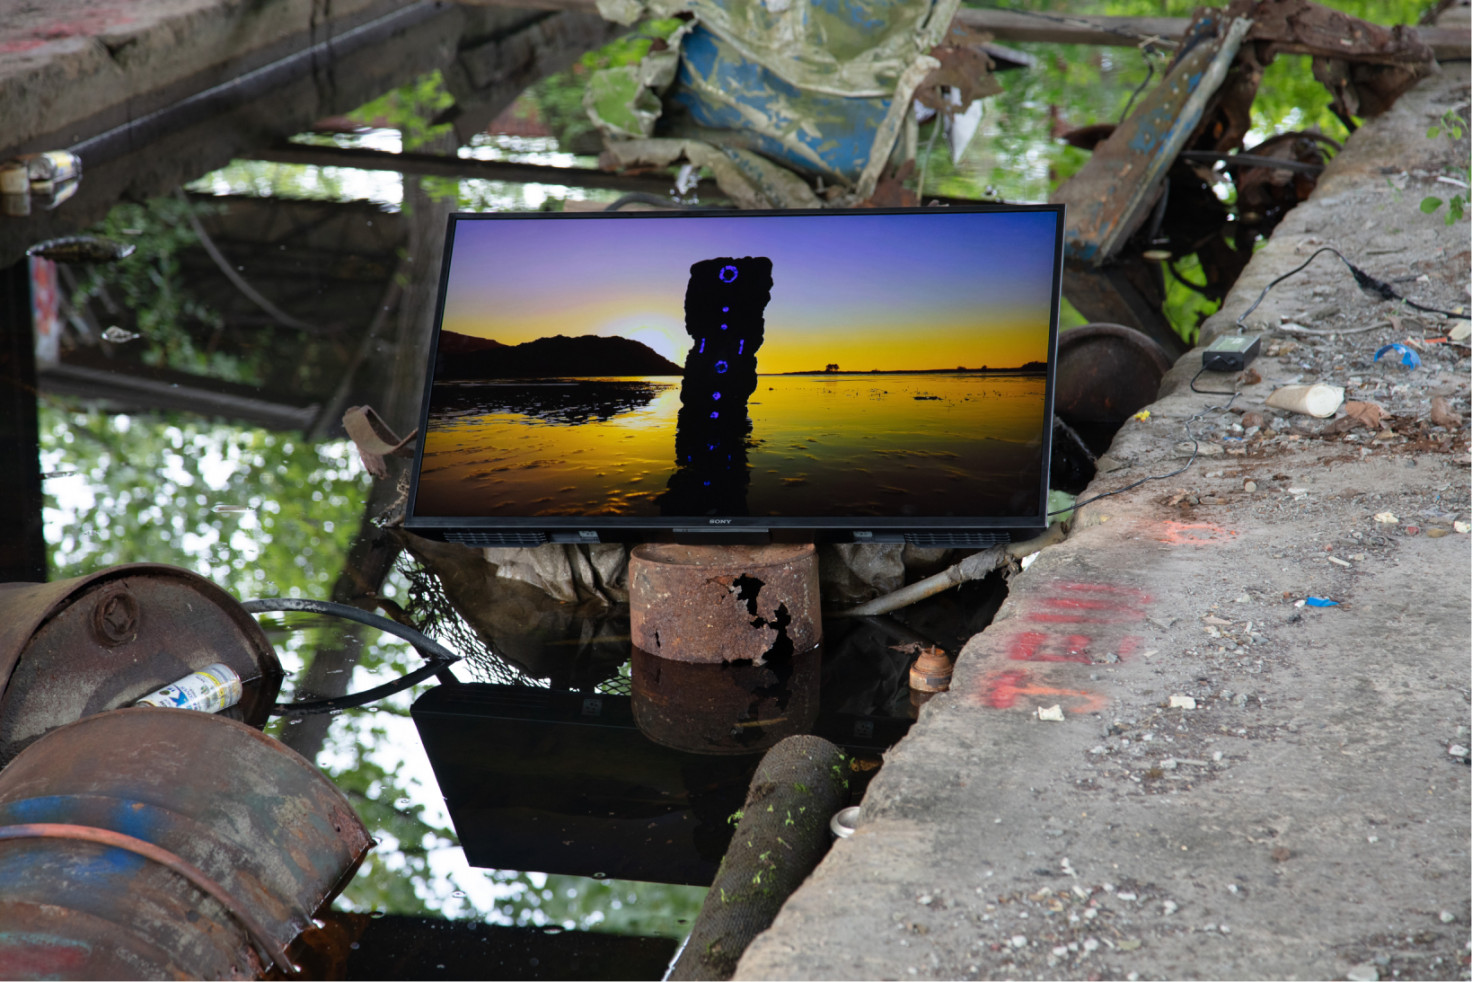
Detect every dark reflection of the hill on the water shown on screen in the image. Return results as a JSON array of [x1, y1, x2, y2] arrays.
[[430, 378, 670, 424]]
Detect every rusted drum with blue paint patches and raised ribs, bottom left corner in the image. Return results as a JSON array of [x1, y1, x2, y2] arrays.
[[0, 708, 369, 979]]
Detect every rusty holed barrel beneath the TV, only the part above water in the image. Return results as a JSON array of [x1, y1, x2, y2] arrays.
[[629, 543, 823, 665]]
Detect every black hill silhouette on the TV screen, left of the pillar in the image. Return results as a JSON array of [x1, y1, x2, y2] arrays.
[[434, 331, 682, 378]]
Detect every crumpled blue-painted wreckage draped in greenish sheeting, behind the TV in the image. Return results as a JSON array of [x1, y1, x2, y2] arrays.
[[584, 0, 960, 208]]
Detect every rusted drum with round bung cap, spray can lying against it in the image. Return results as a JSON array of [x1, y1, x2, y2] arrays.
[[0, 562, 281, 764]]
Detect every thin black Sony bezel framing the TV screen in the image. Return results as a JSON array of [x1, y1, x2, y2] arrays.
[[403, 202, 1064, 545]]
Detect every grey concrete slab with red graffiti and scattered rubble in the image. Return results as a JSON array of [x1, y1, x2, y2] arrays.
[[736, 66, 1472, 979]]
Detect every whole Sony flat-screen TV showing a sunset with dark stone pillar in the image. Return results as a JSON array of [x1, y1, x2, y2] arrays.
[[405, 206, 1063, 545]]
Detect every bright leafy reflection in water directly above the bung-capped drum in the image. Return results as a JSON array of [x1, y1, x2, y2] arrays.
[[40, 400, 365, 598]]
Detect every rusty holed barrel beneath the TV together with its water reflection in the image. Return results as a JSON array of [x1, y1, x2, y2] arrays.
[[629, 543, 823, 754]]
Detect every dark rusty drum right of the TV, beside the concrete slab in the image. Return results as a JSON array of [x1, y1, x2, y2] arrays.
[[1052, 324, 1170, 425]]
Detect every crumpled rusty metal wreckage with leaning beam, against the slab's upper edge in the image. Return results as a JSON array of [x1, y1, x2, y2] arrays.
[[1052, 0, 1434, 353]]
